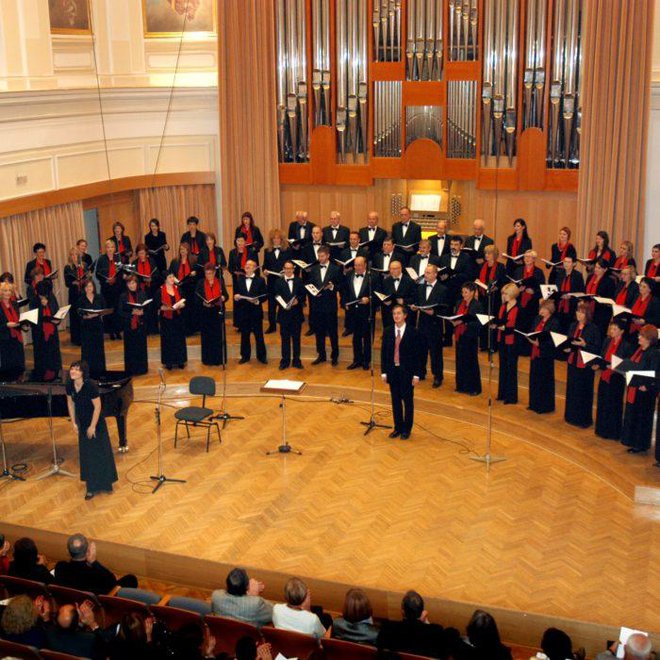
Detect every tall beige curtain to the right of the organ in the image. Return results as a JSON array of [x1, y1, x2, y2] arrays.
[[576, 0, 654, 257]]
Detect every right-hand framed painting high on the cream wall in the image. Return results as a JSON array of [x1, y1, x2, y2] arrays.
[[142, 0, 217, 38]]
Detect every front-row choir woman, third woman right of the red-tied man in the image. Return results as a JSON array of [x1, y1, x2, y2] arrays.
[[527, 300, 560, 414]]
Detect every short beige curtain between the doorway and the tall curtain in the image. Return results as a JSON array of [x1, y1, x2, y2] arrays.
[[138, 185, 221, 249]]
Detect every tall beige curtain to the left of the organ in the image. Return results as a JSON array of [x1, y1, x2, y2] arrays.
[[218, 0, 280, 250]]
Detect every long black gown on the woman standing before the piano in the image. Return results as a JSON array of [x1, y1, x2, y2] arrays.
[[66, 379, 117, 493]]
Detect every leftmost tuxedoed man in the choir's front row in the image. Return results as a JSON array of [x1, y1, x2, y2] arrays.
[[234, 259, 268, 364]]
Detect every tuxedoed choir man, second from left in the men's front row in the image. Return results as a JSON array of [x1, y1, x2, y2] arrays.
[[275, 261, 306, 370]]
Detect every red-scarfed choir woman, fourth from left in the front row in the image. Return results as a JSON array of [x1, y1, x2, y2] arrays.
[[119, 275, 153, 376]]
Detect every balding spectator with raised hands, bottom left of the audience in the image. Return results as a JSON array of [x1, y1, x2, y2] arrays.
[[46, 601, 105, 660]]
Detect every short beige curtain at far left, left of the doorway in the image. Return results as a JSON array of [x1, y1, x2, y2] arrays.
[[0, 202, 85, 305]]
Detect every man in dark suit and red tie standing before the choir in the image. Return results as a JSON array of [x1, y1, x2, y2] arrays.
[[380, 305, 422, 440]]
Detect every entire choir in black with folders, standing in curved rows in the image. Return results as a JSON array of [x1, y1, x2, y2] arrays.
[[0, 214, 660, 466]]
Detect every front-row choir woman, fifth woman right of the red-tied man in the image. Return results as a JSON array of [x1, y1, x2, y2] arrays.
[[592, 320, 633, 440]]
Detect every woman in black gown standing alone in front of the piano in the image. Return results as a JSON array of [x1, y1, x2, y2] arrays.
[[66, 362, 117, 500]]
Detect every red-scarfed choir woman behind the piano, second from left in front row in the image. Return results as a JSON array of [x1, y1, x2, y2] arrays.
[[30, 282, 62, 383]]
